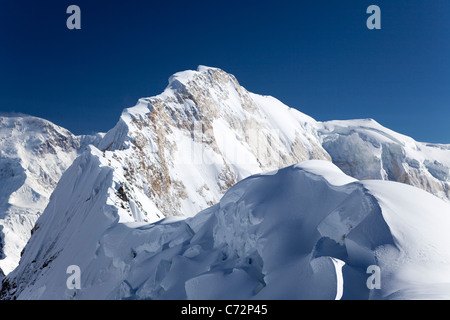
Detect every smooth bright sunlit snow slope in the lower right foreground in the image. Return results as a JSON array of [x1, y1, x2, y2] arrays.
[[363, 181, 450, 300]]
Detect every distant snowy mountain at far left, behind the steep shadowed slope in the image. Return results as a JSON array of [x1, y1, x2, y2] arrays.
[[0, 115, 101, 274]]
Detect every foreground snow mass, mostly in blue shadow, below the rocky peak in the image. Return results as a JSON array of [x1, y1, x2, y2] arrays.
[[1, 160, 450, 299]]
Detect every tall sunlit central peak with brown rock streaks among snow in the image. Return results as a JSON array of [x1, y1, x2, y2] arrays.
[[95, 67, 330, 221]]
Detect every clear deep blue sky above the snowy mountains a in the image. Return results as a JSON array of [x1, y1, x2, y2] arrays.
[[0, 0, 450, 143]]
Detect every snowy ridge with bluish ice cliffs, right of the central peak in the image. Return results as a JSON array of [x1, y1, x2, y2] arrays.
[[319, 119, 450, 201]]
